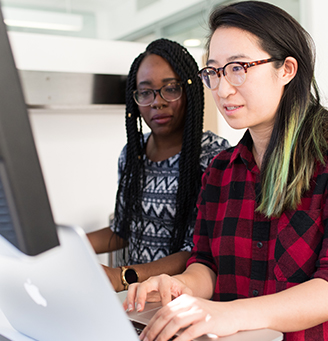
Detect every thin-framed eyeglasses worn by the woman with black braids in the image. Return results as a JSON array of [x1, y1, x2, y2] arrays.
[[133, 82, 182, 107]]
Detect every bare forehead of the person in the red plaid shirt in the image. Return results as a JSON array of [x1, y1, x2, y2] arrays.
[[208, 27, 268, 65]]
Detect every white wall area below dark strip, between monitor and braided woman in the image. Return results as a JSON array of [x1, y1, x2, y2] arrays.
[[30, 107, 126, 231]]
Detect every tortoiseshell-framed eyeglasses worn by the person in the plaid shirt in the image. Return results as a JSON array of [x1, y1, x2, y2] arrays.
[[198, 58, 279, 90]]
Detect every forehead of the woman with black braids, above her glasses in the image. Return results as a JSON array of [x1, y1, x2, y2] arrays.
[[137, 54, 179, 84]]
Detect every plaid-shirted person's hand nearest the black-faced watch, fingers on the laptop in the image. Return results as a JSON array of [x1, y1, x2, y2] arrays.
[[123, 275, 192, 311]]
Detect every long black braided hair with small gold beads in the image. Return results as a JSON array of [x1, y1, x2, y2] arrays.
[[115, 39, 204, 259]]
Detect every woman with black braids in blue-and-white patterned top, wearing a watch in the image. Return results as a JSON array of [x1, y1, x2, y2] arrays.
[[88, 39, 229, 291]]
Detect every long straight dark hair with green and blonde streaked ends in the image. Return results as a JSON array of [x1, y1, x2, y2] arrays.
[[207, 1, 328, 217]]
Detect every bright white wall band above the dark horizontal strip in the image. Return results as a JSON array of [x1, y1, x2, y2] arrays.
[[9, 32, 146, 75]]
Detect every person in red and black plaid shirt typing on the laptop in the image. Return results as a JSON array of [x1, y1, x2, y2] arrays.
[[124, 1, 328, 341]]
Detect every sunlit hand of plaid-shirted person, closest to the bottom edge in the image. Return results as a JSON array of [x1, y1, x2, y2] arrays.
[[140, 294, 238, 341]]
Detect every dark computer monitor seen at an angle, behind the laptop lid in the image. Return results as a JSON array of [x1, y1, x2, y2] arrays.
[[0, 8, 59, 256]]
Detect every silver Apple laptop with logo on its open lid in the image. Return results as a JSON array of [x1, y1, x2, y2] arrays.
[[0, 226, 283, 341]]
